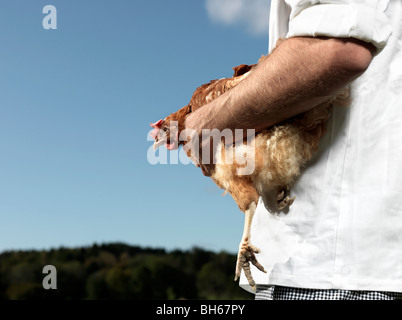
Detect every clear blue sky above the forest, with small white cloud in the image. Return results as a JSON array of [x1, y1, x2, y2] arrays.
[[0, 0, 269, 252]]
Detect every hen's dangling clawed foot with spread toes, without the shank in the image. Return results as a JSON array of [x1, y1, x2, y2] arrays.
[[234, 241, 267, 290]]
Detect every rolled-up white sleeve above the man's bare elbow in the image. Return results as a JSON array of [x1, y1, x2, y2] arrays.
[[286, 0, 392, 51]]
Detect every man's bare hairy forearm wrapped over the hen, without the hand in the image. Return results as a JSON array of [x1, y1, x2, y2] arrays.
[[186, 38, 372, 133]]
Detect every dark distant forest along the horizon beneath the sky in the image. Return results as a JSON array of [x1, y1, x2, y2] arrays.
[[0, 243, 254, 300]]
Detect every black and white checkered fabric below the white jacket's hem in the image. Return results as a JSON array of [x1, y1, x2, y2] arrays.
[[255, 285, 402, 300]]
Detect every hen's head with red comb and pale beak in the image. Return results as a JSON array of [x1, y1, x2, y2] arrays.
[[150, 119, 179, 150]]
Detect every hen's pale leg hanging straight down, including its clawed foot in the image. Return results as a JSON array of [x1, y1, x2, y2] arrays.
[[235, 202, 266, 290]]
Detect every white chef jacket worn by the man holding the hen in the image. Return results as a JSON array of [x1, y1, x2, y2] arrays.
[[240, 0, 402, 292]]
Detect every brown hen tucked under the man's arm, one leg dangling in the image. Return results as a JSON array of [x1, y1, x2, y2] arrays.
[[151, 57, 348, 288]]
